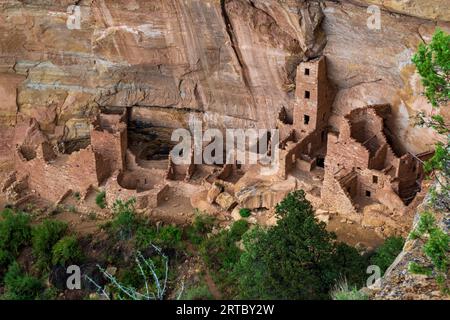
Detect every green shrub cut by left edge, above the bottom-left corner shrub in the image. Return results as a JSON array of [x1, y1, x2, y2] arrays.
[[0, 209, 31, 269]]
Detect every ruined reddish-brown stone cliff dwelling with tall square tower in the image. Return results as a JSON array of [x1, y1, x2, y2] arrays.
[[2, 56, 431, 233]]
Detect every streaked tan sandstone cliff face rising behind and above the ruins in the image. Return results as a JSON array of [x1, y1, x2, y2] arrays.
[[0, 0, 449, 170]]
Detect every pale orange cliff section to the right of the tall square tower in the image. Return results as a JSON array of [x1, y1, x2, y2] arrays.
[[323, 1, 450, 153]]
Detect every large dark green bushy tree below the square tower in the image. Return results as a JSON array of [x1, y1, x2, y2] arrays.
[[237, 191, 365, 299]]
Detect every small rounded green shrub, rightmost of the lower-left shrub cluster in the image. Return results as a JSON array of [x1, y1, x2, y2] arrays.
[[52, 236, 83, 266]]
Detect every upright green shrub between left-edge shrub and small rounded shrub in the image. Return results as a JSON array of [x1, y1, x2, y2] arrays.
[[32, 220, 67, 268]]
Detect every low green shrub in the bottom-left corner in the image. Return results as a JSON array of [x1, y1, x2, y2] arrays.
[[2, 262, 43, 300]]
